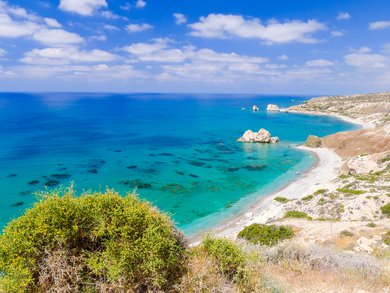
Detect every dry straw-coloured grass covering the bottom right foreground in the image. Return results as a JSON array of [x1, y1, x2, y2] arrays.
[[178, 243, 390, 292]]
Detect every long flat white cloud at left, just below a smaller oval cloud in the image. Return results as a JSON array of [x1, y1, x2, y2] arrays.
[[20, 47, 118, 65]]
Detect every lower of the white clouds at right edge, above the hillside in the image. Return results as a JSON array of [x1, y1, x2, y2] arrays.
[[344, 48, 390, 70]]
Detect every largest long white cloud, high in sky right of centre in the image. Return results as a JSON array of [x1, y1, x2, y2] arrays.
[[189, 14, 326, 44]]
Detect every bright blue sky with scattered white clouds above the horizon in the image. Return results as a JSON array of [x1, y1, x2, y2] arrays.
[[0, 0, 390, 94]]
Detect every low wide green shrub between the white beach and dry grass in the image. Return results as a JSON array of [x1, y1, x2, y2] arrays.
[[238, 224, 294, 246]]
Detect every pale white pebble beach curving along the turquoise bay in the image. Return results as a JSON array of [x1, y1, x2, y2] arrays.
[[190, 111, 366, 245]]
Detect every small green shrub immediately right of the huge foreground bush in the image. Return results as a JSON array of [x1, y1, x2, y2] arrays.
[[202, 236, 245, 279]]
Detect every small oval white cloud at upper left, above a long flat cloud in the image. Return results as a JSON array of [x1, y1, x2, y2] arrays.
[[33, 29, 84, 45]]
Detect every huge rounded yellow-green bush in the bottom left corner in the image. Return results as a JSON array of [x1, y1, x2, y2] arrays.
[[0, 190, 185, 292]]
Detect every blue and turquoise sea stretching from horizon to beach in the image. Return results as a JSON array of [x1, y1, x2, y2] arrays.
[[0, 93, 356, 234]]
